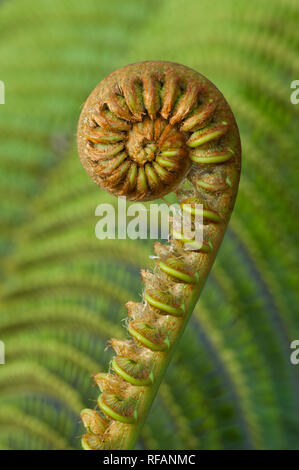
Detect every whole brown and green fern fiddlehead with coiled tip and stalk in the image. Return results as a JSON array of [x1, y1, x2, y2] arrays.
[[77, 61, 241, 450]]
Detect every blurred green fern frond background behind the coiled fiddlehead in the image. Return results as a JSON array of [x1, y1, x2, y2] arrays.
[[0, 0, 299, 449]]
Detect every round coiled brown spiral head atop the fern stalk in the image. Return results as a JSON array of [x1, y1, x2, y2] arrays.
[[78, 62, 240, 201]]
